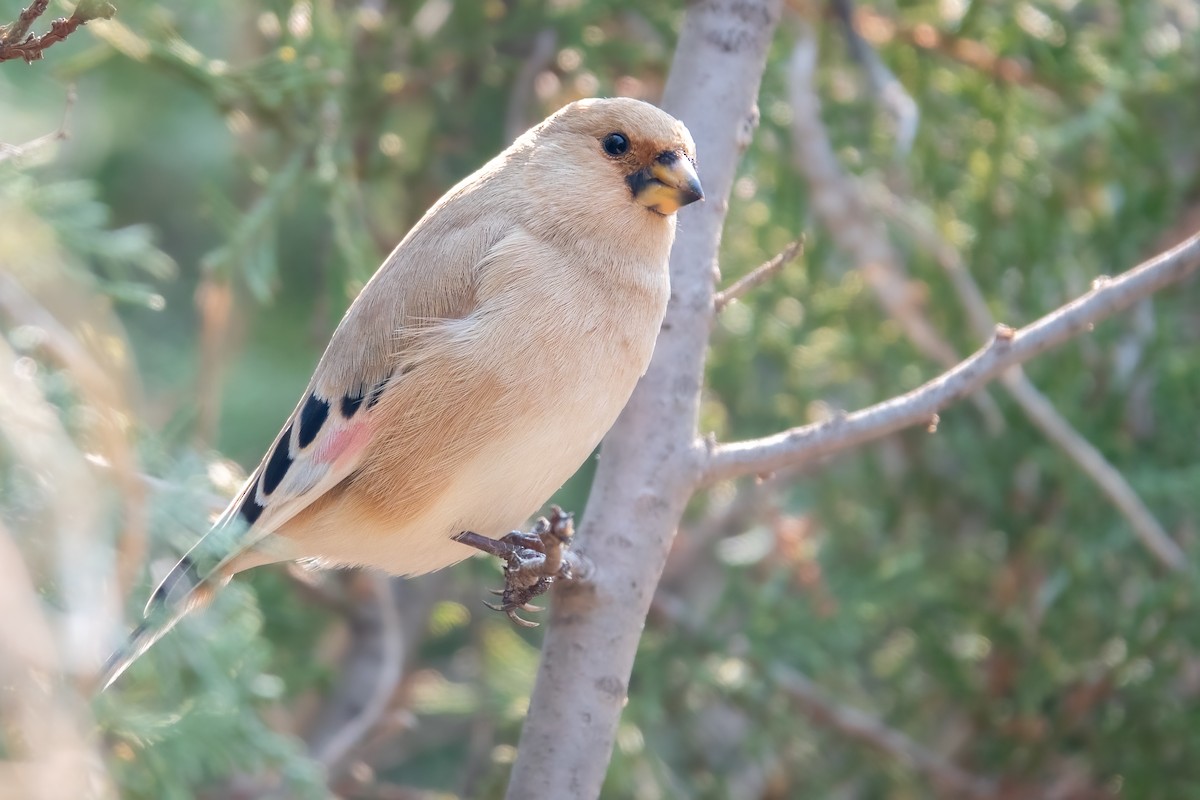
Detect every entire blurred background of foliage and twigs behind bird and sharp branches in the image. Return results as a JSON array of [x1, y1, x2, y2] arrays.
[[0, 0, 1200, 800]]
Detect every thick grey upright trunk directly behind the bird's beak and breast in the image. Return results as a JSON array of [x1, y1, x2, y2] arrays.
[[508, 0, 780, 800]]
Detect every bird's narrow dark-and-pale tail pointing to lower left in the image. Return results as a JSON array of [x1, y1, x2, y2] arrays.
[[98, 554, 229, 691]]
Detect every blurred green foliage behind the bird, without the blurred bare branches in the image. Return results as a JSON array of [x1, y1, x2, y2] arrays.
[[0, 0, 1200, 799]]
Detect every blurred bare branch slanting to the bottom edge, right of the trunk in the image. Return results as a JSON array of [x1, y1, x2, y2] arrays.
[[770, 664, 1000, 800]]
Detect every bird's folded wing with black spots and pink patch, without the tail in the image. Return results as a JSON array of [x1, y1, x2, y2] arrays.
[[178, 217, 511, 587]]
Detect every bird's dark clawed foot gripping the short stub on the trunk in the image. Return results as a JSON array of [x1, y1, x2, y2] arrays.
[[455, 506, 575, 627]]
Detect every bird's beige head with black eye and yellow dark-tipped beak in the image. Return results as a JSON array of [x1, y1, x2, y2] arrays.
[[528, 97, 704, 225]]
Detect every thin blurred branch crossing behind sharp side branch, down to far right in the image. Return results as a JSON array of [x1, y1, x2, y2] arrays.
[[872, 188, 1188, 570]]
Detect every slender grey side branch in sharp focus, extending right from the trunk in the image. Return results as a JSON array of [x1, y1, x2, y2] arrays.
[[702, 227, 1200, 483]]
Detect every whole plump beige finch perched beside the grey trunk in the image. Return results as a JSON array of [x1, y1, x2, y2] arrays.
[[105, 97, 704, 688]]
